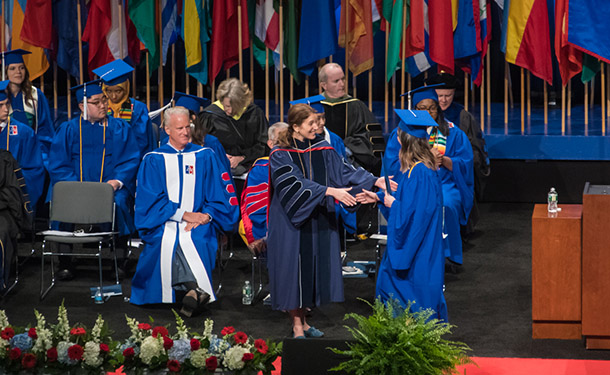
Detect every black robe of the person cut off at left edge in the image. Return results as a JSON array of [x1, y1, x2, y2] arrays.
[[0, 149, 32, 290]]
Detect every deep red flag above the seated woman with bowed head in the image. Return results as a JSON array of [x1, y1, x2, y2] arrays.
[[209, 0, 250, 82]]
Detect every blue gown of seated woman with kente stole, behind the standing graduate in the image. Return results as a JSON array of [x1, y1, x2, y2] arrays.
[[382, 123, 474, 264]]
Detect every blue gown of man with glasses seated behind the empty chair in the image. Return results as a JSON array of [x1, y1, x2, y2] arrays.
[[49, 116, 140, 235]]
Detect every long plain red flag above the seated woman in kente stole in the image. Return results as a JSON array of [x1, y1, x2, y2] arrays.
[[428, 0, 455, 74]]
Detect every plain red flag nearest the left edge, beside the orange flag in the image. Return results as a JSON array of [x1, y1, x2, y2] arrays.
[[20, 0, 53, 49]]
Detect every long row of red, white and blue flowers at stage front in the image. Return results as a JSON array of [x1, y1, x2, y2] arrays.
[[0, 304, 282, 375]]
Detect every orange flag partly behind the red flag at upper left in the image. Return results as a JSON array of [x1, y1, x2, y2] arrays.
[[4, 0, 49, 80]]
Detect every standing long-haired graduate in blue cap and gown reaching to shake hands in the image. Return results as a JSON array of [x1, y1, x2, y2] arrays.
[[357, 110, 448, 322]]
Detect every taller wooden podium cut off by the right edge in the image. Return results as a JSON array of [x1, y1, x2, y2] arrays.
[[582, 183, 610, 349]]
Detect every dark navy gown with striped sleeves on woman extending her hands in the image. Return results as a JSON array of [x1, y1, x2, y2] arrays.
[[267, 138, 376, 310]]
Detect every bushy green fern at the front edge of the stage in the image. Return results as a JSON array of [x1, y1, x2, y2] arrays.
[[331, 300, 472, 375]]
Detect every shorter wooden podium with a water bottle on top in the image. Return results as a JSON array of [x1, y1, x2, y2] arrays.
[[532, 204, 580, 339]]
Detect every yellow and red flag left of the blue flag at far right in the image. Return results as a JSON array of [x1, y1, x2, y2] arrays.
[[505, 0, 552, 85]]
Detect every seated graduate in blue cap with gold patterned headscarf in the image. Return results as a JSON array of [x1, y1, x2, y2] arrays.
[[93, 59, 157, 157]]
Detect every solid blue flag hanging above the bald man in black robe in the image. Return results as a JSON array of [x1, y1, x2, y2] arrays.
[[299, 0, 339, 76]]
